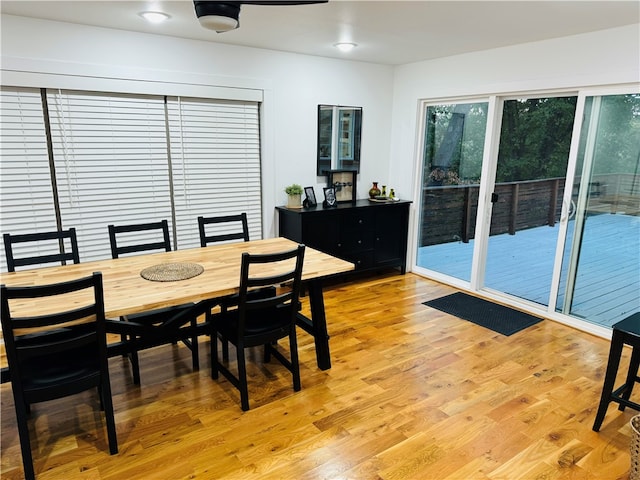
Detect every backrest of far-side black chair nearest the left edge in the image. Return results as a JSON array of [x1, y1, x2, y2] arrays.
[[3, 228, 80, 272]]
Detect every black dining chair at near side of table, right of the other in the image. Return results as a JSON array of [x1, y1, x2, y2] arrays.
[[209, 245, 305, 411]]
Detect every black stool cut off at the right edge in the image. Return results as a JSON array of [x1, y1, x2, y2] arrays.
[[593, 312, 640, 432]]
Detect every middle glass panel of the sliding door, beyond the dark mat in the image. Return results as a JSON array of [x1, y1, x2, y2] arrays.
[[484, 96, 577, 305]]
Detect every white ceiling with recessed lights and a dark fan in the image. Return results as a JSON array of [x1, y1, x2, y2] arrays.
[[0, 0, 640, 65]]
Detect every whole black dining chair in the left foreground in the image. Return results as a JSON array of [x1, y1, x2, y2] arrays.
[[0, 273, 118, 479]]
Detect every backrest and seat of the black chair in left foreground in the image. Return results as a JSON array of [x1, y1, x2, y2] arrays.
[[0, 273, 108, 403]]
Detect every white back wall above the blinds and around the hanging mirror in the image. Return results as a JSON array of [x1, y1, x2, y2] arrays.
[[0, 15, 393, 237]]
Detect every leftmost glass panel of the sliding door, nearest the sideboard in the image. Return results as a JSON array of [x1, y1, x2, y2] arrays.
[[416, 102, 489, 281]]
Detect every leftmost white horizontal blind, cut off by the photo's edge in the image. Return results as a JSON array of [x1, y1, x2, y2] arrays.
[[0, 87, 57, 272]]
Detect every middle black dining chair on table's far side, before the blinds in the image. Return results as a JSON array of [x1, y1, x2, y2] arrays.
[[108, 220, 200, 385]]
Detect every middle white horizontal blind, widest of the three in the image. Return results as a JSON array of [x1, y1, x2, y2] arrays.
[[47, 90, 171, 260]]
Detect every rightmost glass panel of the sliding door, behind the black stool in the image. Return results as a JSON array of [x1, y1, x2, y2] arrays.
[[556, 94, 640, 326]]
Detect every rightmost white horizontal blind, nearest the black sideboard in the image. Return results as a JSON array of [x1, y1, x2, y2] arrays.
[[167, 97, 262, 248]]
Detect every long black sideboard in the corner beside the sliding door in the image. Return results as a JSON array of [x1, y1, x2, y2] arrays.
[[276, 200, 411, 274]]
